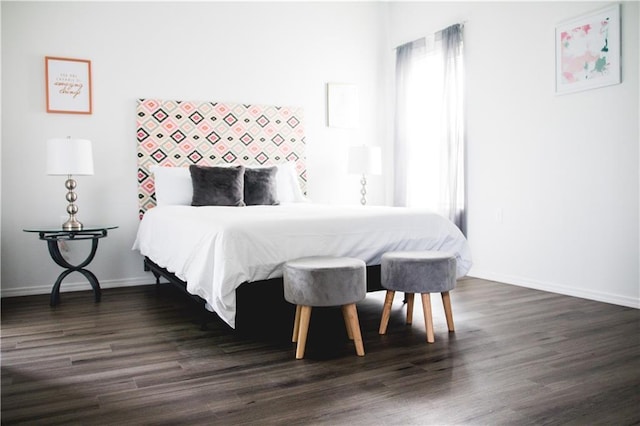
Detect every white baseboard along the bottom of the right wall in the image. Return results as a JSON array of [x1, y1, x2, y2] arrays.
[[469, 269, 640, 309]]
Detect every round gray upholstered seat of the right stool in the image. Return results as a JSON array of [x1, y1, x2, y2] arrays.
[[381, 251, 456, 293]]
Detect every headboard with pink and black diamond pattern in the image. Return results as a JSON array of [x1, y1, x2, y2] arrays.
[[136, 99, 307, 218]]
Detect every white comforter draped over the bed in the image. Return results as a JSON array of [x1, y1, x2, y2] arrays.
[[133, 203, 471, 327]]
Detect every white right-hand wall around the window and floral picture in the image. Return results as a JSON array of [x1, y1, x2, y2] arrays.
[[390, 2, 640, 307]]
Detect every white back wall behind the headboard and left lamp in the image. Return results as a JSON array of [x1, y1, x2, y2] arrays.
[[0, 1, 384, 297]]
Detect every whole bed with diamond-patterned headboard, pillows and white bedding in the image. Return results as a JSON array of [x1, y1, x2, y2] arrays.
[[133, 99, 471, 328]]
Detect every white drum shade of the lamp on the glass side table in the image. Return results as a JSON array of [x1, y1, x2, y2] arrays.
[[47, 138, 93, 175]]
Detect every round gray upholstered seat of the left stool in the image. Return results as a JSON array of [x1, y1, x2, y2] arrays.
[[283, 256, 367, 306]]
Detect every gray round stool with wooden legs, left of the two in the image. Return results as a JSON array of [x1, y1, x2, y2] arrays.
[[283, 256, 367, 359]]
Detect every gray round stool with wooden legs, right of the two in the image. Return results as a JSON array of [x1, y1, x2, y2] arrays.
[[379, 251, 456, 343]]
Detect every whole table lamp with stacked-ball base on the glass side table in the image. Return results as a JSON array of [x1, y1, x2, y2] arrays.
[[47, 137, 93, 231]]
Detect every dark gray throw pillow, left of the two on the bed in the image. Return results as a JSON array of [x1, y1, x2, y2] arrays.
[[189, 165, 245, 207]]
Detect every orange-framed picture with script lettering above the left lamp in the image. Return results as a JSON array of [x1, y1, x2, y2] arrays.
[[45, 56, 91, 114]]
